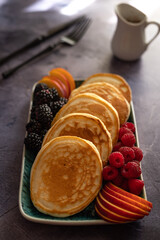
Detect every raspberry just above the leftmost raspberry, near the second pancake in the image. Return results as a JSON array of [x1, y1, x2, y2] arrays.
[[109, 152, 124, 168]]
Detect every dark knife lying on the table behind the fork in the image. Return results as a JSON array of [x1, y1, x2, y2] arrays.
[[0, 16, 84, 65]]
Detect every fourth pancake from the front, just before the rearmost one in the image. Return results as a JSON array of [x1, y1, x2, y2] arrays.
[[70, 82, 130, 125]]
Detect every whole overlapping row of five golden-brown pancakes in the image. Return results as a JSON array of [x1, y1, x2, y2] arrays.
[[30, 73, 132, 217]]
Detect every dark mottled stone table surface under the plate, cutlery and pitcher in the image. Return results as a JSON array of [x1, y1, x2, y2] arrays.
[[0, 0, 160, 240]]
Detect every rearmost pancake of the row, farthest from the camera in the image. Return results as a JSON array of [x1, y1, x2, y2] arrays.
[[82, 73, 132, 103]]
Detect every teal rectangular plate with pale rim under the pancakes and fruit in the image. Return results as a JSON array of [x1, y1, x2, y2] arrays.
[[19, 80, 147, 225]]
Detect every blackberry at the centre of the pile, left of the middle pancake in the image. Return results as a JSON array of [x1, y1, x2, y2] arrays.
[[34, 104, 53, 129]]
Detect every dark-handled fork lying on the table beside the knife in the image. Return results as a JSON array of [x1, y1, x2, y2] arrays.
[[2, 16, 91, 78]]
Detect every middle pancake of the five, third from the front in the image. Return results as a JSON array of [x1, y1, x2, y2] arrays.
[[52, 93, 120, 145]]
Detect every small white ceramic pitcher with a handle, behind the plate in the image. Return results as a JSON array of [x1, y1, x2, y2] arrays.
[[111, 3, 160, 61]]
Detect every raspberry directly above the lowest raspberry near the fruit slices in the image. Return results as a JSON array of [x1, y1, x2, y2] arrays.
[[121, 162, 141, 178]]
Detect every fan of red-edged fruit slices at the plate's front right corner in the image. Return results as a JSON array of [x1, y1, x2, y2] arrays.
[[95, 182, 152, 223]]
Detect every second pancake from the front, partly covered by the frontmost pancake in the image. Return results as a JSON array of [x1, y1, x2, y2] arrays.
[[42, 113, 112, 166]]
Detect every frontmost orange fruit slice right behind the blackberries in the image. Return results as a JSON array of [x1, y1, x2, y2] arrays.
[[39, 76, 64, 97]]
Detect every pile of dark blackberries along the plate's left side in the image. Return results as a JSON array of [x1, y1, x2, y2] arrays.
[[24, 83, 67, 153]]
